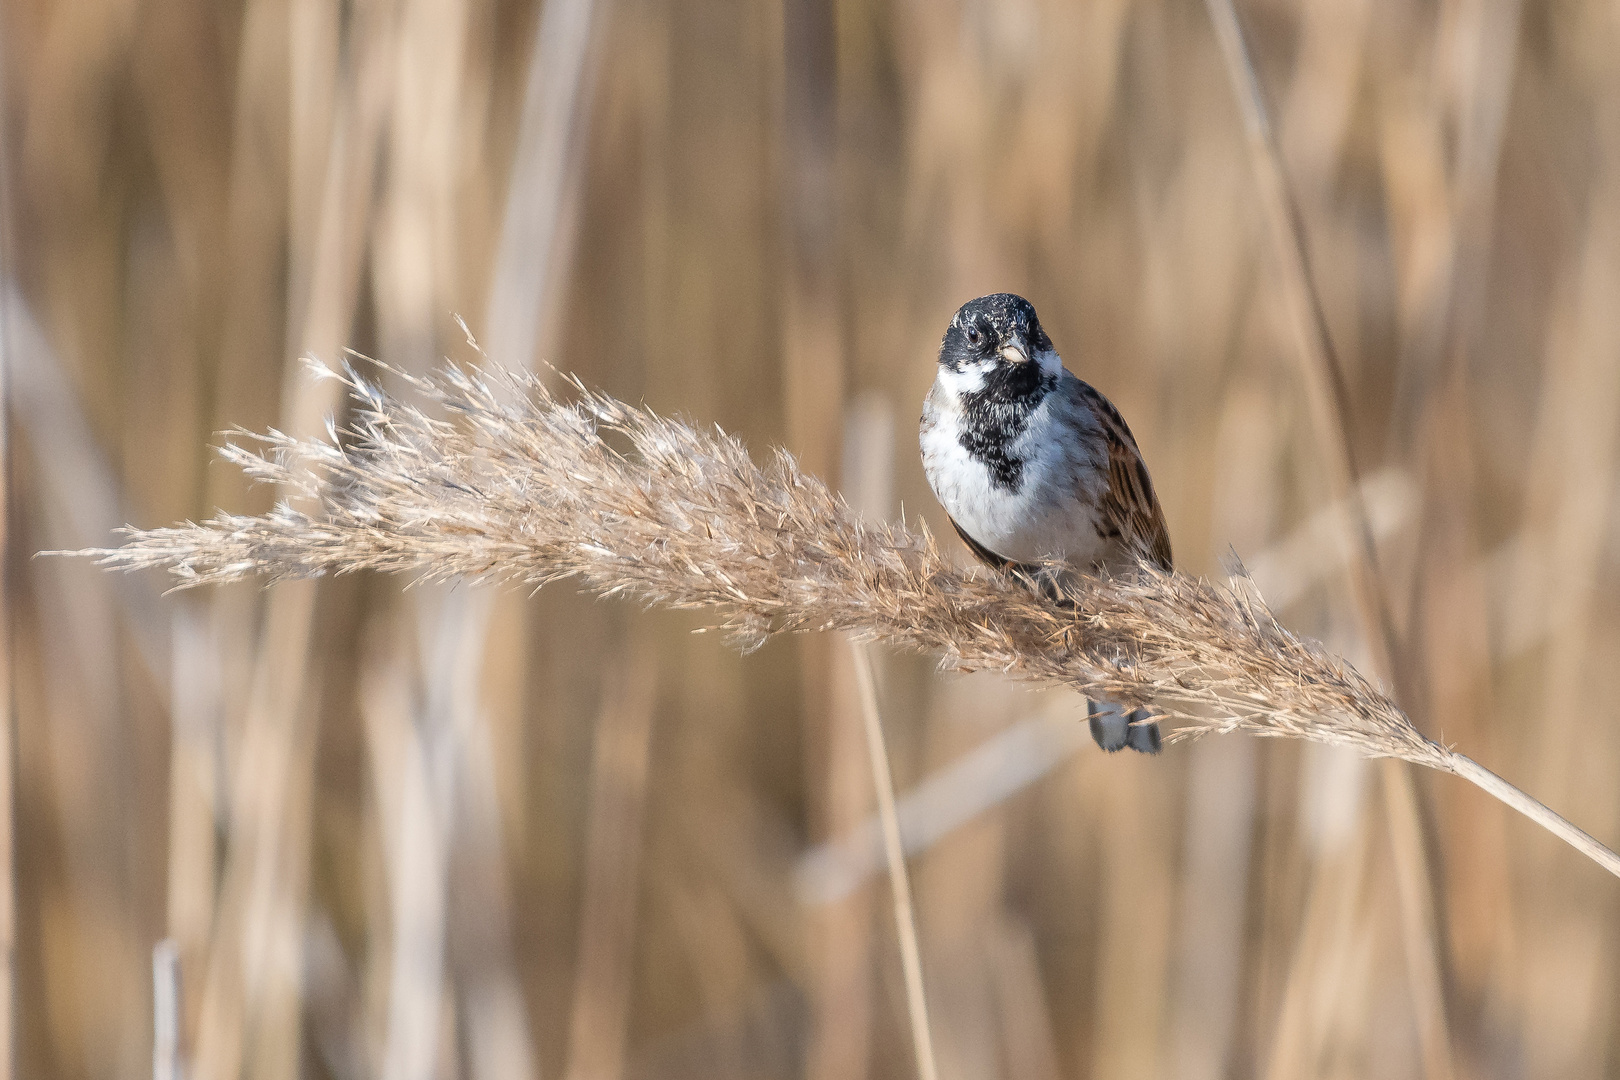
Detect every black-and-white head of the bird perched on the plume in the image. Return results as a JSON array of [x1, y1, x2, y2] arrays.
[[940, 293, 1063, 397]]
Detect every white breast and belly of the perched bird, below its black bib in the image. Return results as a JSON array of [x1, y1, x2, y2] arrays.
[[920, 378, 1105, 567]]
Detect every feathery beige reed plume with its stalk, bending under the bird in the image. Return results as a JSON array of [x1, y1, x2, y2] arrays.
[[78, 361, 1620, 876]]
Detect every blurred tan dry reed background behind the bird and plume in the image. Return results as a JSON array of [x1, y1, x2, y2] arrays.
[[0, 0, 1620, 1080]]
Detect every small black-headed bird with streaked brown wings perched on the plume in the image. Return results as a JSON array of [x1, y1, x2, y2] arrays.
[[919, 293, 1170, 753]]
